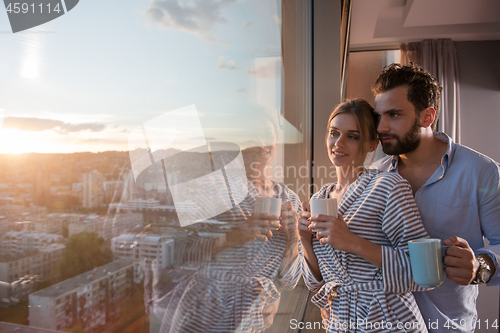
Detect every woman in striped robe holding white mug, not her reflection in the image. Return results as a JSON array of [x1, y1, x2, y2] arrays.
[[298, 99, 428, 332]]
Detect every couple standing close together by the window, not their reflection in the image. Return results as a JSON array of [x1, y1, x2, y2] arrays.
[[298, 64, 500, 332]]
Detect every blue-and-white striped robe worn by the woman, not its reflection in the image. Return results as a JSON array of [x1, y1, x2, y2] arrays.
[[301, 170, 428, 332]]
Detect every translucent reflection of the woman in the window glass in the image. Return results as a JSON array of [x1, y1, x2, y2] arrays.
[[155, 104, 300, 333]]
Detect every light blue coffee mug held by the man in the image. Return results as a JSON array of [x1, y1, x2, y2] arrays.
[[408, 238, 448, 288]]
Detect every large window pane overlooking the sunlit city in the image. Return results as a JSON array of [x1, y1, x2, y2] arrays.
[[0, 0, 309, 332]]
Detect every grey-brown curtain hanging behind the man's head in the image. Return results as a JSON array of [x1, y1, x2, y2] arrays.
[[400, 39, 461, 143]]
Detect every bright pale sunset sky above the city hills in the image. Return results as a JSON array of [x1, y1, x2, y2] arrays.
[[0, 0, 292, 153]]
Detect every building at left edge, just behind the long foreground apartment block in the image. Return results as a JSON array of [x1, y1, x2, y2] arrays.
[[0, 243, 66, 283]]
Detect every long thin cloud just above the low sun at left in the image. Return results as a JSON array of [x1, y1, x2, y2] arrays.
[[3, 117, 106, 134]]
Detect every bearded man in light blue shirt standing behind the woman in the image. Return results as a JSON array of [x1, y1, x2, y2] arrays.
[[373, 64, 500, 332]]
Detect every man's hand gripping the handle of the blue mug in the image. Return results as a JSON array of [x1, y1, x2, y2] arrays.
[[443, 236, 479, 286]]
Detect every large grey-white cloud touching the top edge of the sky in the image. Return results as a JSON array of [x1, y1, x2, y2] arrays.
[[145, 0, 239, 43]]
